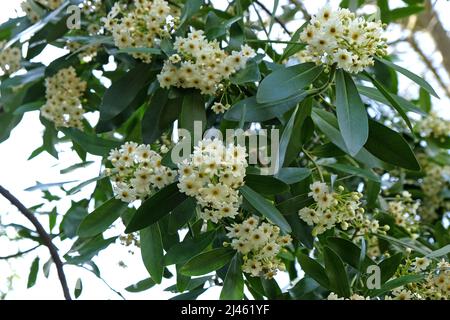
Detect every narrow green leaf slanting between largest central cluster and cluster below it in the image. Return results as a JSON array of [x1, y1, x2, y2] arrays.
[[240, 186, 292, 233]]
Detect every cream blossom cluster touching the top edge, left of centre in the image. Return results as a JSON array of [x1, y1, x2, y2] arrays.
[[102, 0, 179, 63]]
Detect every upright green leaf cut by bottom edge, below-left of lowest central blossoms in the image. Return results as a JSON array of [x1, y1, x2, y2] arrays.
[[220, 253, 244, 300]]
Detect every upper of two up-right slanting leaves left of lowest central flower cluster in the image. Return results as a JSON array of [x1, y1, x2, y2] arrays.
[[163, 231, 216, 266]]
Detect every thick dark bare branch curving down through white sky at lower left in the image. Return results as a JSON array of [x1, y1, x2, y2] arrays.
[[0, 186, 72, 300]]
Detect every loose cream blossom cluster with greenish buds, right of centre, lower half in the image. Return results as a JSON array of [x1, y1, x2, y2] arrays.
[[299, 182, 387, 236]]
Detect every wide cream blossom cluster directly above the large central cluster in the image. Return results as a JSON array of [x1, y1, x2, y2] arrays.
[[158, 30, 256, 95]]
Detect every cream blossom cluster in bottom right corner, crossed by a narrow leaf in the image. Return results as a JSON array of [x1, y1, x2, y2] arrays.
[[385, 257, 450, 300]]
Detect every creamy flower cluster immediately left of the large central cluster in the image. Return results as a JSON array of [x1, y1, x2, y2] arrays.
[[106, 142, 176, 202]]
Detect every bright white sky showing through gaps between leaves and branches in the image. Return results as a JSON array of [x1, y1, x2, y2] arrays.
[[0, 0, 450, 299]]
